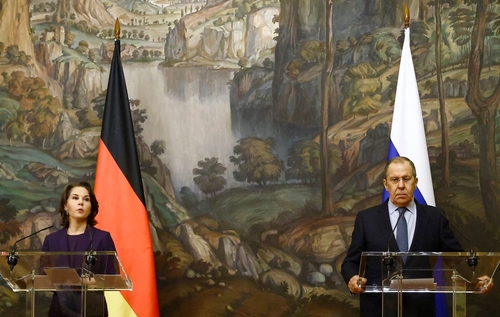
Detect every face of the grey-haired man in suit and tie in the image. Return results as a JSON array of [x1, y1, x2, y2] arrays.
[[384, 162, 418, 207]]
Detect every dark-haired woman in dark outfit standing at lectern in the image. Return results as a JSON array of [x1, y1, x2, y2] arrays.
[[41, 182, 116, 317]]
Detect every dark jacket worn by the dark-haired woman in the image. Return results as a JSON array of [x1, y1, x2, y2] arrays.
[[40, 226, 117, 317]]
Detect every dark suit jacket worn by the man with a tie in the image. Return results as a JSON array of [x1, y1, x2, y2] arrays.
[[341, 201, 462, 317]]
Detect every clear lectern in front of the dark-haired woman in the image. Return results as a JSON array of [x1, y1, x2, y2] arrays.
[[0, 251, 133, 317]]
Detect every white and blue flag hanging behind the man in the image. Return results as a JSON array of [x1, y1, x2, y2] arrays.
[[383, 28, 448, 317]]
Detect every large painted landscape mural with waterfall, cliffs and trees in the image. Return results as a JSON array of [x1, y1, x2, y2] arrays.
[[0, 0, 500, 317]]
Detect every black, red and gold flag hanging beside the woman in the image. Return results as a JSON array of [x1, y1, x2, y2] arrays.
[[95, 19, 159, 317]]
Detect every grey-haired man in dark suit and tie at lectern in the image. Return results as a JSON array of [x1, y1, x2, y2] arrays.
[[341, 157, 493, 317]]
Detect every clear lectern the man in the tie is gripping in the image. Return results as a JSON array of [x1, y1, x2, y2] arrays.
[[359, 252, 500, 317]]
